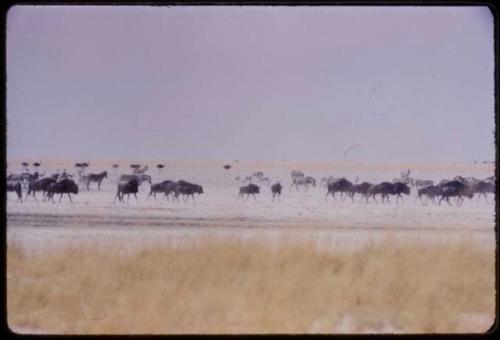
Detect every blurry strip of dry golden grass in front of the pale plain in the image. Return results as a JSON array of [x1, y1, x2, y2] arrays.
[[7, 235, 495, 334]]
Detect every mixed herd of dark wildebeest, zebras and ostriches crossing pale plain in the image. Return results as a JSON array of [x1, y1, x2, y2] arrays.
[[3, 163, 496, 206]]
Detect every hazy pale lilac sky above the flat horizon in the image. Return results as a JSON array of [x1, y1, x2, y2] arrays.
[[7, 6, 494, 162]]
